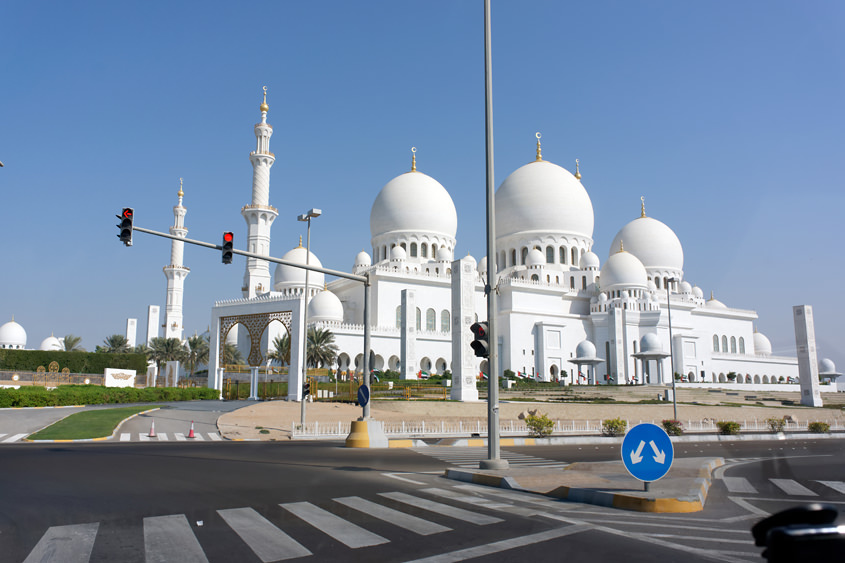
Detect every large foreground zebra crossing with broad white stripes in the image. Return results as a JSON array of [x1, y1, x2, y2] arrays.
[[19, 486, 520, 563]]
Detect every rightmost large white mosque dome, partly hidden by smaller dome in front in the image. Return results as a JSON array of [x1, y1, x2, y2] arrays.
[[610, 216, 684, 272]]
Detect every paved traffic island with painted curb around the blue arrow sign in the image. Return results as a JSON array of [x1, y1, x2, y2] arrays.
[[446, 457, 725, 512]]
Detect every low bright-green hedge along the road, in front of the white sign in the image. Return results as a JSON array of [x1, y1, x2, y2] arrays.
[[0, 385, 219, 408]]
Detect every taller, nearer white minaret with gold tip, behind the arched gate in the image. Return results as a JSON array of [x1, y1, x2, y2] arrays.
[[241, 86, 279, 297]]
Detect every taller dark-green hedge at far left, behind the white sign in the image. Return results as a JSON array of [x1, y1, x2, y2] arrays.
[[0, 350, 147, 375]]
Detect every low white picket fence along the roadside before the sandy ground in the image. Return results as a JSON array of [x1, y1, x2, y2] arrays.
[[291, 418, 845, 439]]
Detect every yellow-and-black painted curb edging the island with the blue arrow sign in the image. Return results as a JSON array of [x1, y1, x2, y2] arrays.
[[445, 458, 725, 513]]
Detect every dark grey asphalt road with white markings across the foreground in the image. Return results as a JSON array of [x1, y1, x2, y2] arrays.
[[0, 440, 845, 563]]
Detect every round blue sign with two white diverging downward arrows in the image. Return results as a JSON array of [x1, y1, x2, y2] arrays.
[[622, 423, 675, 482]]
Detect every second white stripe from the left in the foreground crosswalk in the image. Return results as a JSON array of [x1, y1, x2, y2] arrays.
[[144, 514, 208, 563]]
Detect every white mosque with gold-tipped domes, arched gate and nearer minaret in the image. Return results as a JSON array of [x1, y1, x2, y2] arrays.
[[203, 91, 835, 399]]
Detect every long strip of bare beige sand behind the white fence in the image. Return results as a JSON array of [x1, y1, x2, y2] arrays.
[[217, 392, 845, 440]]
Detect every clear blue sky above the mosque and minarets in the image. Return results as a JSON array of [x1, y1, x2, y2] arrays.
[[0, 0, 845, 369]]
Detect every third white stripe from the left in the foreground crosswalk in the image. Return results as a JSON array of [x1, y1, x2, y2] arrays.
[[217, 508, 311, 563]]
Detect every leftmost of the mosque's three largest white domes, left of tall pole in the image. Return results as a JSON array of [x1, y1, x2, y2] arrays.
[[370, 171, 458, 239]]
